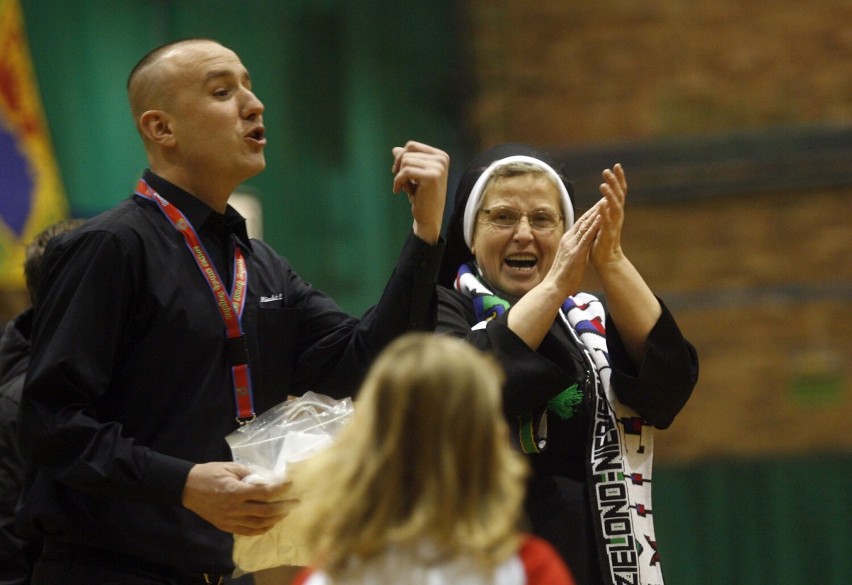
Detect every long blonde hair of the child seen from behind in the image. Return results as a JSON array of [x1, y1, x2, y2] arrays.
[[295, 333, 528, 577]]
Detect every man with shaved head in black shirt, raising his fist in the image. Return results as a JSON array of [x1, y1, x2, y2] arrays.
[[20, 39, 449, 585]]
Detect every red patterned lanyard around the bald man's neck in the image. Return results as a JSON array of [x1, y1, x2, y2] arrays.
[[136, 179, 255, 424]]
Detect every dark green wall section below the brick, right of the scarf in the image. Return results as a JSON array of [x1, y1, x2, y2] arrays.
[[653, 454, 852, 585]]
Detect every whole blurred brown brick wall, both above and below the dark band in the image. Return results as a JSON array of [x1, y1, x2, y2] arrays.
[[466, 0, 852, 461]]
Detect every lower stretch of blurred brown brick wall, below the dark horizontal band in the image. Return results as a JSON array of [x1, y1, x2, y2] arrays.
[[620, 189, 852, 461]]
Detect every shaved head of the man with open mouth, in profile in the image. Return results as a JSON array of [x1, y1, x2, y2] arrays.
[[127, 39, 266, 195]]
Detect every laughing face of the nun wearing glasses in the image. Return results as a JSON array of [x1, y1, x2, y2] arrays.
[[471, 173, 565, 300]]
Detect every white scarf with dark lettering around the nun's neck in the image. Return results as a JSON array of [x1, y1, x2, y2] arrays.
[[455, 264, 663, 585]]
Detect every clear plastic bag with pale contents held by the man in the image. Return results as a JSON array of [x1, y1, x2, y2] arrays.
[[225, 392, 353, 574]]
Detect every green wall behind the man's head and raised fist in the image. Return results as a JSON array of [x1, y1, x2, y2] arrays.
[[22, 0, 466, 314]]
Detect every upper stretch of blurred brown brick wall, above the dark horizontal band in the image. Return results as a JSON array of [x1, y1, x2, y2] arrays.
[[466, 0, 852, 147]]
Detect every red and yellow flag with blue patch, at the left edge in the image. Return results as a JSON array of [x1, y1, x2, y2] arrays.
[[0, 0, 68, 289]]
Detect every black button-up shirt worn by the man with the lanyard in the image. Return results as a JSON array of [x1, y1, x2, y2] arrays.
[[20, 171, 443, 572]]
